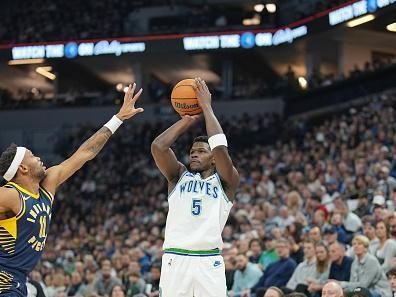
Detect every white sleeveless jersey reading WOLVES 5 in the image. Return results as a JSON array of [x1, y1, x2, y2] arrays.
[[164, 171, 232, 251]]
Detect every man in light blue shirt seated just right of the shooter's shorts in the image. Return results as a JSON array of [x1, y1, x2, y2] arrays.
[[232, 254, 263, 296]]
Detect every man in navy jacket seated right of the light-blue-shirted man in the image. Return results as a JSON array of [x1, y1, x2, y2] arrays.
[[250, 238, 296, 297]]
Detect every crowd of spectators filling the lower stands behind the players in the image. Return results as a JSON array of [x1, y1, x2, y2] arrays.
[[11, 90, 396, 297]]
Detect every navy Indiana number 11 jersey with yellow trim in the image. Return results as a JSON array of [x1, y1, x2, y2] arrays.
[[0, 182, 54, 277]]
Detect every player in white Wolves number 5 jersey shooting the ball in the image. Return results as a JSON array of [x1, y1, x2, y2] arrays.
[[151, 78, 239, 297]]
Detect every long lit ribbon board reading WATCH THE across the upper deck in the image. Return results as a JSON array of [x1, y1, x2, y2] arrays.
[[4, 0, 396, 60]]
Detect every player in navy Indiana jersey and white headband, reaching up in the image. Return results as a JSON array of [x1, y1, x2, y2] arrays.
[[0, 84, 143, 296]]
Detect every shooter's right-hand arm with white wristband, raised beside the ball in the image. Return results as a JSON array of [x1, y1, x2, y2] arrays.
[[195, 78, 239, 199]]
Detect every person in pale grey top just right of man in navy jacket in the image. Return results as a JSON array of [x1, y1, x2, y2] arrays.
[[286, 239, 316, 293]]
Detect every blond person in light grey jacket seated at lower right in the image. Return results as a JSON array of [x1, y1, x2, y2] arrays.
[[340, 235, 392, 297]]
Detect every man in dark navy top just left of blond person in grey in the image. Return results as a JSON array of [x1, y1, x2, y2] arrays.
[[329, 242, 353, 281]]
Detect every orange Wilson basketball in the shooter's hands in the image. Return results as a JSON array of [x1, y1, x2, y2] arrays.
[[171, 79, 202, 115]]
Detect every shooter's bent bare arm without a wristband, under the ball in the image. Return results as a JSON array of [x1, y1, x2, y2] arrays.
[[151, 116, 199, 184]]
